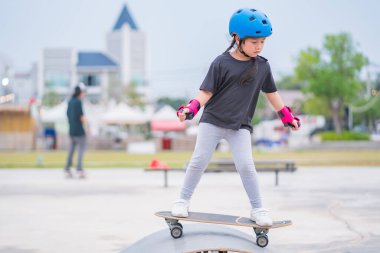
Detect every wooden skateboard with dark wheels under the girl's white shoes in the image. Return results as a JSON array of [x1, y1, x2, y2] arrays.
[[155, 211, 292, 248]]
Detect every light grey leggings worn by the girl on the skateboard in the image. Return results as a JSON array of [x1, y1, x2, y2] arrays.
[[180, 123, 262, 208]]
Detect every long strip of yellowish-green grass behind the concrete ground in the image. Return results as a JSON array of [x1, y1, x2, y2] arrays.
[[0, 149, 380, 168]]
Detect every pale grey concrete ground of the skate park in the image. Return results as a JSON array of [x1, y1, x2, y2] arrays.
[[0, 168, 380, 253]]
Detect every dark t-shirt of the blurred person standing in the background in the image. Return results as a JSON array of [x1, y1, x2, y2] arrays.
[[67, 97, 85, 136]]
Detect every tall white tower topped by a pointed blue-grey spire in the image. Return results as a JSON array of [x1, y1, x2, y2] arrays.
[[106, 4, 147, 85]]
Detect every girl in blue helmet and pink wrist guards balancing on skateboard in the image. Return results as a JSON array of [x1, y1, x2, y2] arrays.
[[172, 9, 300, 226]]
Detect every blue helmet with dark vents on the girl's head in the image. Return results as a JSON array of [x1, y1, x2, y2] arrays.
[[229, 8, 272, 39]]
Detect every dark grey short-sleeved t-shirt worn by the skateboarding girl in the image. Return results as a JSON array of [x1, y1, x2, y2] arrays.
[[199, 52, 277, 132]]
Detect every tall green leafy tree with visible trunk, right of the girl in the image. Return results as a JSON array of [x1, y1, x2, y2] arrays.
[[295, 33, 368, 133]]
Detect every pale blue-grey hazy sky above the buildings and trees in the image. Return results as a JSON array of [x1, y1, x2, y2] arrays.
[[0, 0, 380, 97]]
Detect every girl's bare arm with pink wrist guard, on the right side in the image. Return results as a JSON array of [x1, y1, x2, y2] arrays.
[[264, 91, 301, 130]]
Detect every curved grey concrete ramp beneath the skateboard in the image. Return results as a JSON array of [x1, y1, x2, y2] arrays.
[[120, 224, 278, 253]]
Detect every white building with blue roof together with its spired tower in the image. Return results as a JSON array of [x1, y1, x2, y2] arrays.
[[38, 5, 147, 103]]
